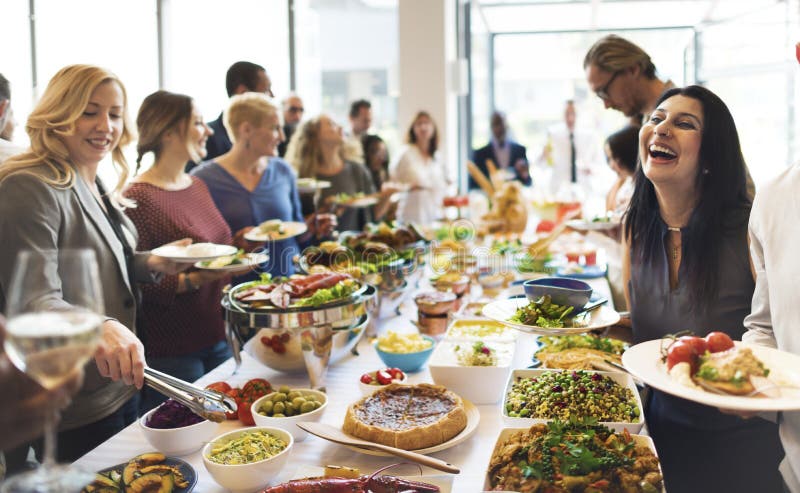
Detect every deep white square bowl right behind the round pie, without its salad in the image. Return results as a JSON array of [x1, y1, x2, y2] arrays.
[[428, 340, 514, 404]]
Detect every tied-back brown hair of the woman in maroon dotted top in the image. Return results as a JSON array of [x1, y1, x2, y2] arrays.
[[136, 91, 195, 173]]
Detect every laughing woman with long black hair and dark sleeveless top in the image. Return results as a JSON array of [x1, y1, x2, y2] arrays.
[[623, 86, 783, 493]]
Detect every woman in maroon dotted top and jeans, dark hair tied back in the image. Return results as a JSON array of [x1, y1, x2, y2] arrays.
[[125, 91, 248, 414]]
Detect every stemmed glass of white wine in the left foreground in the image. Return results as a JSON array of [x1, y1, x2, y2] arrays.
[[2, 249, 104, 493]]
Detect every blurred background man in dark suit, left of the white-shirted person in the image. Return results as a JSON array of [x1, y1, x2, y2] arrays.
[[469, 111, 532, 190]]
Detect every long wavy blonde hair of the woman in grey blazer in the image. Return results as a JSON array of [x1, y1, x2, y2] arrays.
[[0, 65, 135, 206]]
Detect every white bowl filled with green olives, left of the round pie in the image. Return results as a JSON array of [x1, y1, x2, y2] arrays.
[[250, 385, 328, 442]]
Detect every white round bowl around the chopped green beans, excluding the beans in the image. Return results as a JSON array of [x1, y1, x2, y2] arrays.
[[202, 426, 294, 493]]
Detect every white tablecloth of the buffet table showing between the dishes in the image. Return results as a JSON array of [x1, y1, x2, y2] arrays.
[[76, 278, 609, 493]]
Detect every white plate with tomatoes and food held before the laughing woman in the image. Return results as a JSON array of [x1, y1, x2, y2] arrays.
[[622, 332, 800, 412]]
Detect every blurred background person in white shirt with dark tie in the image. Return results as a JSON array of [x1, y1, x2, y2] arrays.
[[538, 99, 599, 198]]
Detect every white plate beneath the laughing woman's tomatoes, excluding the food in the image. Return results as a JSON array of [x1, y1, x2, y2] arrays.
[[622, 339, 800, 412]]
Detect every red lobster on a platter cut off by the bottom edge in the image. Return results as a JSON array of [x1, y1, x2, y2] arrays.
[[282, 464, 453, 493]]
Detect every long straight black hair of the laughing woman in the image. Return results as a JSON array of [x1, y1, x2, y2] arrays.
[[625, 86, 752, 313]]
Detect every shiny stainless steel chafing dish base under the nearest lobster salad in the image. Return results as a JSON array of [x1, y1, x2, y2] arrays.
[[222, 284, 378, 388]]
